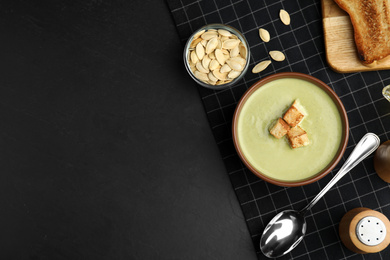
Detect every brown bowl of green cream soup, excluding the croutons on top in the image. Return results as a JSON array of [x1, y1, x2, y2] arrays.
[[232, 72, 349, 187]]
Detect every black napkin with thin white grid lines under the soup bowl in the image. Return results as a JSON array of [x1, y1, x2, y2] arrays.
[[167, 0, 390, 259]]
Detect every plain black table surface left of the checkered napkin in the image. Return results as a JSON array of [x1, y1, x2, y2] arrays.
[[0, 0, 256, 260]]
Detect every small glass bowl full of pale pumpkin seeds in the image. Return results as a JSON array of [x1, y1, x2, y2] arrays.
[[184, 24, 250, 90]]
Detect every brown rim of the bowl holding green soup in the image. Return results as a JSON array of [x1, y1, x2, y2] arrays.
[[232, 72, 349, 187]]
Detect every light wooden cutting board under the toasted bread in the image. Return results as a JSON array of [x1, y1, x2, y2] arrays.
[[322, 0, 390, 73]]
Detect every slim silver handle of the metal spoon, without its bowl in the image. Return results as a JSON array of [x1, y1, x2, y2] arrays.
[[300, 133, 380, 215]]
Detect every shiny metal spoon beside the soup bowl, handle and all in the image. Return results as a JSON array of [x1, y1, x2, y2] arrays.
[[260, 133, 380, 258]]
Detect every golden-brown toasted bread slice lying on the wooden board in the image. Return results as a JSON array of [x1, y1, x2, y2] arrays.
[[335, 0, 390, 64]]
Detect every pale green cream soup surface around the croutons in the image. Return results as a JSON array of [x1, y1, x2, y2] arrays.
[[237, 78, 342, 181]]
